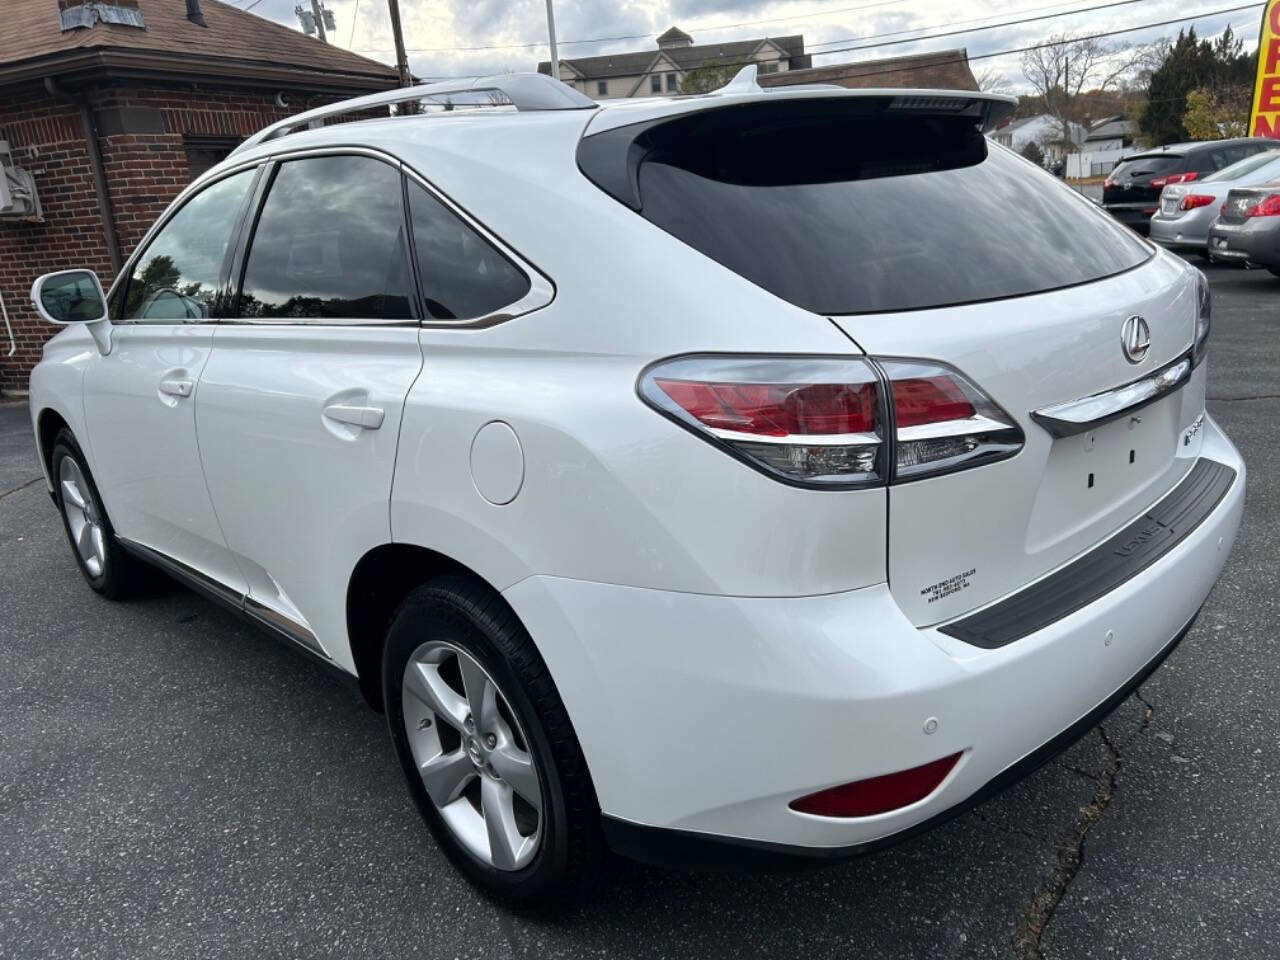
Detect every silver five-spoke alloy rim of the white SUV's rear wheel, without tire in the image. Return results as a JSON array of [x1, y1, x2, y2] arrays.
[[402, 640, 544, 870]]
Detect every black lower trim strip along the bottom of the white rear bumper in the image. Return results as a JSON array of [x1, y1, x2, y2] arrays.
[[603, 611, 1199, 869]]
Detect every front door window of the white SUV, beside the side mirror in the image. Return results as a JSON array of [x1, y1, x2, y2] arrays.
[[123, 170, 253, 324]]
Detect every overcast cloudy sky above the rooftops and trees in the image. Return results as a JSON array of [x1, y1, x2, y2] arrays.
[[229, 0, 1261, 90]]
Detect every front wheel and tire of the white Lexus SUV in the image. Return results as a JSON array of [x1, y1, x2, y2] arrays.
[[49, 428, 145, 600]]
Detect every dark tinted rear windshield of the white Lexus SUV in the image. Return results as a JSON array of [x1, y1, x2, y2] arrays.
[[580, 99, 1151, 315]]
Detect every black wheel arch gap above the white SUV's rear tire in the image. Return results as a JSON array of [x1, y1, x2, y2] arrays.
[[347, 543, 509, 713]]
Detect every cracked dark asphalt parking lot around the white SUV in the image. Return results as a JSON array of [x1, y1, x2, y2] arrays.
[[0, 268, 1280, 957]]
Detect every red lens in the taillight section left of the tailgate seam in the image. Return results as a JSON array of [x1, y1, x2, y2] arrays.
[[654, 376, 876, 436]]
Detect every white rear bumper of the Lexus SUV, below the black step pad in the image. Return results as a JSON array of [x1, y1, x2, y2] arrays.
[[506, 417, 1244, 861]]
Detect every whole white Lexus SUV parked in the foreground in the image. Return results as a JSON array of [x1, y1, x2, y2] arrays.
[[31, 74, 1244, 902]]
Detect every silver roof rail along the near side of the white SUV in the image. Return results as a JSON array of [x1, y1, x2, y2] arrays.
[[232, 73, 598, 156]]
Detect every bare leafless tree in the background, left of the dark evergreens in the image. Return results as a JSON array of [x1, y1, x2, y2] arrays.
[[1023, 33, 1139, 154]]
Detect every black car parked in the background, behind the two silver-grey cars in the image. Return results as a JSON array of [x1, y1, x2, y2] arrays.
[[1102, 137, 1280, 236]]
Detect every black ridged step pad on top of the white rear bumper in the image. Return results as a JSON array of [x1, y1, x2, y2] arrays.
[[940, 460, 1235, 650]]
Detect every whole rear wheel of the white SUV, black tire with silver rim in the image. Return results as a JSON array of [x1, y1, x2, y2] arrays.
[[383, 576, 603, 908]]
